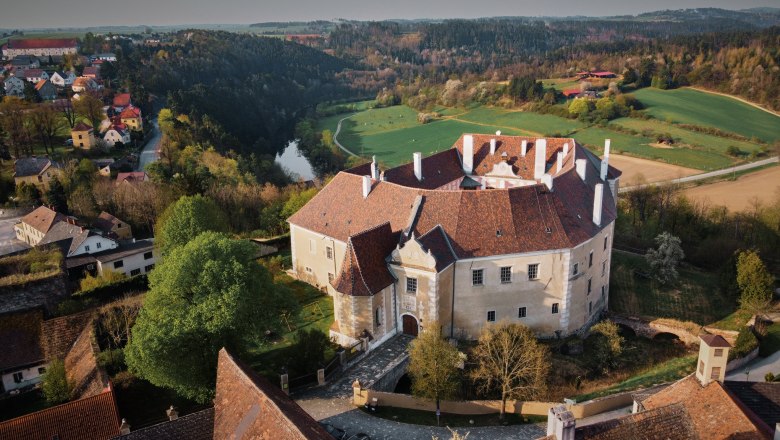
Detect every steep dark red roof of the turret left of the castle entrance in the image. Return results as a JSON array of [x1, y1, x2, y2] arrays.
[[331, 222, 399, 296]]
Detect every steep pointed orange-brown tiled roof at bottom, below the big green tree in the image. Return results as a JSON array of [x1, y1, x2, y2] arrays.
[[213, 348, 333, 440]]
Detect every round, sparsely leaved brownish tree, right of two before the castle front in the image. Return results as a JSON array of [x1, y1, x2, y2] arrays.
[[471, 321, 550, 419]]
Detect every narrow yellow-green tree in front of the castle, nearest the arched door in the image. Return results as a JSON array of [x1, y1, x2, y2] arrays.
[[408, 322, 463, 422]]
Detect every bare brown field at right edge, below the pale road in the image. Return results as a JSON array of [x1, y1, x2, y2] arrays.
[[683, 166, 780, 211]]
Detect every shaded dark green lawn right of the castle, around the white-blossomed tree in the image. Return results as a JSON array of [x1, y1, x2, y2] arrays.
[[609, 251, 736, 325]]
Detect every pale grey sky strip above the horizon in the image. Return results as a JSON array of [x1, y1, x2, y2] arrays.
[[0, 0, 780, 29]]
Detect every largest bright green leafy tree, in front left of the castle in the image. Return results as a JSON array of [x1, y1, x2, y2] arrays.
[[125, 232, 297, 403]]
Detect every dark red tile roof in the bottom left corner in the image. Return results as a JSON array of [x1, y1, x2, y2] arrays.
[[0, 391, 119, 440]]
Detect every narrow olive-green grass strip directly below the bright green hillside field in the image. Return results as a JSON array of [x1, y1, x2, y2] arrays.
[[612, 118, 760, 154]]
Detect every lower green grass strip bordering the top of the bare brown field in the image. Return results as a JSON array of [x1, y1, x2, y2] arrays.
[[572, 127, 732, 170]]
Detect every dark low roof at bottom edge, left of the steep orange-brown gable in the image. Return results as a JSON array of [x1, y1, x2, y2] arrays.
[[117, 408, 214, 440]]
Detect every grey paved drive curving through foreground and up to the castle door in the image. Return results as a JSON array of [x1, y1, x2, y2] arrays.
[[293, 336, 545, 440]]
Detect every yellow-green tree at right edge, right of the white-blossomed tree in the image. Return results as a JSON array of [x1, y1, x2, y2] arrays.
[[737, 250, 775, 314]]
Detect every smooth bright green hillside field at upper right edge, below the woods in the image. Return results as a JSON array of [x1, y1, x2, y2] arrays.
[[634, 87, 780, 142]]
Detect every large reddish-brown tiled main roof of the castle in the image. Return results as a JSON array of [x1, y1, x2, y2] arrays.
[[288, 135, 620, 265]]
